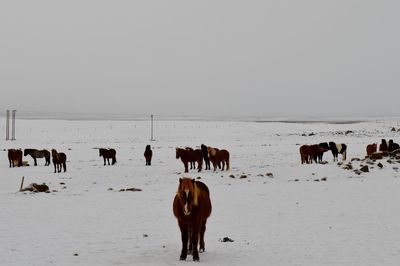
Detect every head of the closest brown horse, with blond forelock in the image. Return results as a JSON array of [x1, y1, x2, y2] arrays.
[[177, 177, 198, 216]]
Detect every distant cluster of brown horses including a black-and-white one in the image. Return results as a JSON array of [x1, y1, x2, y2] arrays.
[[299, 141, 347, 164]]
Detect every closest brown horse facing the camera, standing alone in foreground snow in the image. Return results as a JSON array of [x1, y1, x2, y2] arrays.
[[173, 178, 212, 261]]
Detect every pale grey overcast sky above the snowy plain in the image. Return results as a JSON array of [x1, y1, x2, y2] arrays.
[[0, 0, 400, 116]]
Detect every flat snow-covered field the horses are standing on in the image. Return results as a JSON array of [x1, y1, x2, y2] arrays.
[[0, 118, 400, 266]]
